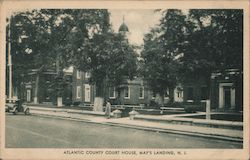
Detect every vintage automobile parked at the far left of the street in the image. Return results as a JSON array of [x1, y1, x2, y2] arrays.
[[5, 100, 30, 115]]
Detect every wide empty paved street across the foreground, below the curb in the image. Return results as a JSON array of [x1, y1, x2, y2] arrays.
[[5, 114, 242, 149]]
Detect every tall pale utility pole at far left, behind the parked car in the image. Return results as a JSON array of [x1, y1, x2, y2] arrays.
[[8, 17, 12, 103]]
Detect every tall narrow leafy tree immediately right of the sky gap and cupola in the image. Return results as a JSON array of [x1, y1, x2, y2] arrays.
[[142, 10, 185, 105]]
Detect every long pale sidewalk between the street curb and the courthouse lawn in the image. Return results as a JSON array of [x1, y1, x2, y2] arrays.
[[26, 106, 243, 142]]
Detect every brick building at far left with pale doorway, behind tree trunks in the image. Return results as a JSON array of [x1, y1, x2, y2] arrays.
[[20, 69, 72, 104]]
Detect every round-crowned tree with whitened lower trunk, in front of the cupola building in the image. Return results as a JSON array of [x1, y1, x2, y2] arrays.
[[74, 30, 137, 110]]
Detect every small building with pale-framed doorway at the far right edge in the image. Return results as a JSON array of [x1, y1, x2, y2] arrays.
[[211, 69, 243, 111]]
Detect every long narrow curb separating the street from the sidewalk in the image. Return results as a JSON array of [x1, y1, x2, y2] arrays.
[[29, 110, 243, 143]]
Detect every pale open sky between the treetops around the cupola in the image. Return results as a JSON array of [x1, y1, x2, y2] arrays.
[[109, 9, 162, 45]]
